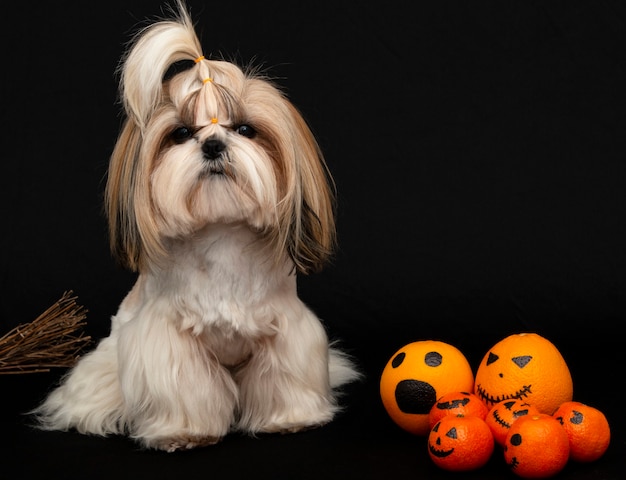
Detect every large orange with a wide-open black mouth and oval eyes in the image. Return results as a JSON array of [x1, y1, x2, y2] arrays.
[[380, 340, 474, 436]]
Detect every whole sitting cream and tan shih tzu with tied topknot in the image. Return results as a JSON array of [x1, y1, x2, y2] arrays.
[[34, 1, 359, 451]]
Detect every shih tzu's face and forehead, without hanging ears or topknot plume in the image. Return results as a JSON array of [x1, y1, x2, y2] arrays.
[[143, 60, 282, 236]]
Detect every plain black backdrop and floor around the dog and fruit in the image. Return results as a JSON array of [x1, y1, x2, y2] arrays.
[[0, 0, 626, 480]]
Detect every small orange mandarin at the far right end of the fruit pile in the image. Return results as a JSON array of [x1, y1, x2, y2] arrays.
[[552, 402, 611, 462]]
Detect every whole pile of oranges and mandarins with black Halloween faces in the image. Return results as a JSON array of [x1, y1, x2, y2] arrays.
[[380, 333, 611, 478]]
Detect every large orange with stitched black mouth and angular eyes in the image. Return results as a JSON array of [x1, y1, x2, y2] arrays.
[[474, 333, 574, 415]]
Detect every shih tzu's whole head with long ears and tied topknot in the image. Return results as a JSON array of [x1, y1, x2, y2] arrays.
[[106, 3, 335, 273]]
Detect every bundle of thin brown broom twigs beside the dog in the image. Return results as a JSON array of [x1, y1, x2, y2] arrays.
[[0, 291, 91, 374]]
